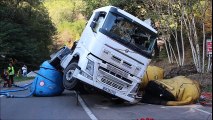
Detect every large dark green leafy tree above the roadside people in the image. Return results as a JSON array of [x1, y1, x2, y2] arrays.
[[0, 0, 55, 70]]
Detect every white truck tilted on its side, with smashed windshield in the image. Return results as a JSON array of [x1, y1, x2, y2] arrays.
[[50, 6, 157, 103]]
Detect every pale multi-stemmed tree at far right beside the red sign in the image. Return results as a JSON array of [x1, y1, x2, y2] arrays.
[[184, 0, 211, 73]]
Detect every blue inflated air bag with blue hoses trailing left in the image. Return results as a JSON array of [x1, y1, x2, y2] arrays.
[[0, 61, 64, 98]]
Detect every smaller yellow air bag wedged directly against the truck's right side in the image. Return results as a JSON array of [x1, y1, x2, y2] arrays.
[[141, 66, 164, 90]]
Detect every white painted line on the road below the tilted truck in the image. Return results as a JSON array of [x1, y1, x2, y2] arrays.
[[78, 95, 98, 120]]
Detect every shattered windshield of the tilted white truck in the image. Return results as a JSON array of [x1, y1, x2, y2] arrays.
[[103, 13, 156, 53]]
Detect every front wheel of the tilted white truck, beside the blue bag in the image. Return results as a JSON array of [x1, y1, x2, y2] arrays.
[[63, 61, 79, 90]]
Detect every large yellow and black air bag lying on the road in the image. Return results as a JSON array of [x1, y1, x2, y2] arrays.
[[142, 76, 201, 106]]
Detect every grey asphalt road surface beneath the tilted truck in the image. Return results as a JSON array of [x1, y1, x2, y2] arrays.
[[0, 81, 212, 120]]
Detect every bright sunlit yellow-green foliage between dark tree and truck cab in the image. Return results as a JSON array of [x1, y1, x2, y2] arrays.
[[44, 0, 86, 46]]
